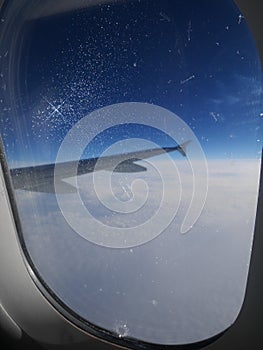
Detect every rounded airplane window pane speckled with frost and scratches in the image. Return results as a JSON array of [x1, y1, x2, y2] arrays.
[[0, 0, 263, 345]]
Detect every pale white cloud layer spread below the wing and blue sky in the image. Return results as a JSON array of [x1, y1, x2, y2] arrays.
[[14, 160, 260, 344]]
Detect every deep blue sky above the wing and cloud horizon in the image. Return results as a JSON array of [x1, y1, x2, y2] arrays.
[[1, 0, 263, 162]]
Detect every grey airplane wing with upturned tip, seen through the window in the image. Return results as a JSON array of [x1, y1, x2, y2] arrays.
[[10, 141, 190, 193]]
